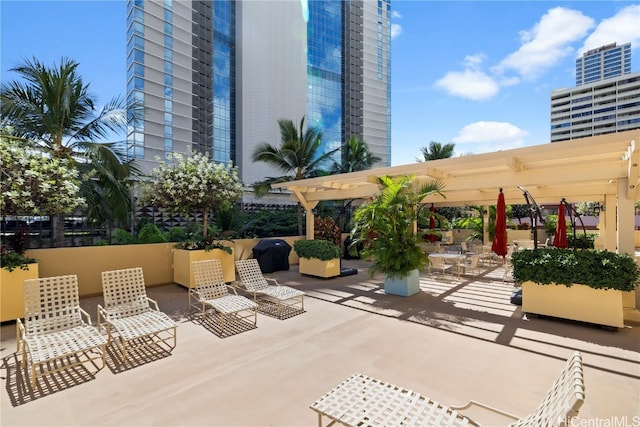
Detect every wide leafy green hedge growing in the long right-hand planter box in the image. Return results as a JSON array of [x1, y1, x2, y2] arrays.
[[511, 248, 640, 291]]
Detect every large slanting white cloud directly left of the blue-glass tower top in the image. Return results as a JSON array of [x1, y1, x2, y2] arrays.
[[493, 7, 594, 80]]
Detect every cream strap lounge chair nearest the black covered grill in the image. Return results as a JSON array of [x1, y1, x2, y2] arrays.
[[236, 258, 304, 319]]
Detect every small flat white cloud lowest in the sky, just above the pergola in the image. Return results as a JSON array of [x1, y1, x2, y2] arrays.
[[451, 121, 529, 153]]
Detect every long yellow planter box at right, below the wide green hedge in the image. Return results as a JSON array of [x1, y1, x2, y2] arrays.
[[522, 282, 624, 328]]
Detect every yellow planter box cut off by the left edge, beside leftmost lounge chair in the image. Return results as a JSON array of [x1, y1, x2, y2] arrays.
[[0, 263, 38, 322]]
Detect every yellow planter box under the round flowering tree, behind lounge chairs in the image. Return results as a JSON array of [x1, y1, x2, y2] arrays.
[[173, 248, 236, 288]]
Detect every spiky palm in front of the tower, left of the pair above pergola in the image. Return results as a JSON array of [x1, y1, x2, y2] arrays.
[[253, 116, 339, 234]]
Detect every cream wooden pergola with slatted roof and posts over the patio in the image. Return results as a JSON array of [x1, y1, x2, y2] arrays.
[[273, 129, 640, 254]]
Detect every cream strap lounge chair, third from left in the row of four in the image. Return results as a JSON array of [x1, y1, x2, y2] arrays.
[[189, 259, 258, 335]]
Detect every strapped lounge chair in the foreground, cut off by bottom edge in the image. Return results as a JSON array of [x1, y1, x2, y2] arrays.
[[311, 352, 585, 427]]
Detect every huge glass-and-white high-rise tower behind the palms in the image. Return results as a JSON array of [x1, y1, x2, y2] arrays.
[[127, 0, 391, 191]]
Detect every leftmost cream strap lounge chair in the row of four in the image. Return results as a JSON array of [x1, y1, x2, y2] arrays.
[[16, 275, 107, 388]]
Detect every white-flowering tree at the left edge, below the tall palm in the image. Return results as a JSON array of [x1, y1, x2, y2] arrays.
[[0, 138, 85, 215]]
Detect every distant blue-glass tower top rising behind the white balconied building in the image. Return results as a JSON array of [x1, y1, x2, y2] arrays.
[[576, 43, 631, 86]]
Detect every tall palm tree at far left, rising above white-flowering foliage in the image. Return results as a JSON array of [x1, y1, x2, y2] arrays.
[[0, 58, 140, 246]]
